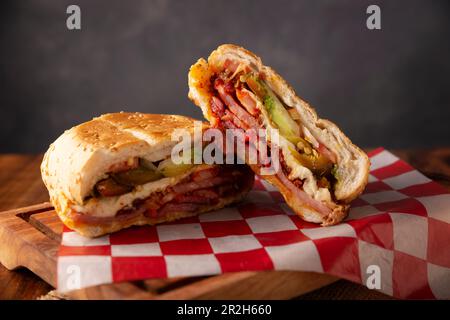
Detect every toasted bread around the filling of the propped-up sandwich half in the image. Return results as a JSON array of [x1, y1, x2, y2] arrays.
[[188, 44, 370, 225]]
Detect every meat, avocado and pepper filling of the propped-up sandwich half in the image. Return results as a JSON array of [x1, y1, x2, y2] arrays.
[[210, 60, 339, 216]]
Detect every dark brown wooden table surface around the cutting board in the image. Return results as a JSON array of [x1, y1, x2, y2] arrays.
[[0, 147, 450, 299]]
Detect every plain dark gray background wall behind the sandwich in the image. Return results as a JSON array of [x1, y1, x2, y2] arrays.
[[0, 0, 450, 152]]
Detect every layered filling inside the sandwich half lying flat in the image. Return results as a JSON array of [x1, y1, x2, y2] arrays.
[[70, 159, 254, 224]]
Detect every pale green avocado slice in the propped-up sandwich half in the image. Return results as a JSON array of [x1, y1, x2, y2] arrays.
[[245, 75, 300, 145]]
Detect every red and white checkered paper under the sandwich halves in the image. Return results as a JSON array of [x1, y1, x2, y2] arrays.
[[58, 148, 450, 299]]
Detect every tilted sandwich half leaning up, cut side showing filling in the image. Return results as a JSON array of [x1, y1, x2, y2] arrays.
[[189, 45, 370, 226]]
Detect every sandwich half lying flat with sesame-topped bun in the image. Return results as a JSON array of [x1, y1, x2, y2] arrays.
[[41, 113, 254, 237]]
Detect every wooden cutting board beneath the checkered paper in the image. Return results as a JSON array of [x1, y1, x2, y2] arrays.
[[0, 202, 338, 299]]
